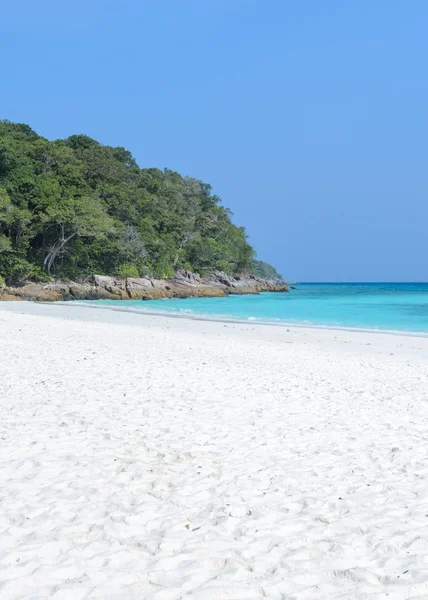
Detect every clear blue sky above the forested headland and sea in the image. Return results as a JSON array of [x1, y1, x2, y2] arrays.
[[0, 0, 428, 281]]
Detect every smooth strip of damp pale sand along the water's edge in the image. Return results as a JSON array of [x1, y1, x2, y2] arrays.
[[0, 301, 428, 360]]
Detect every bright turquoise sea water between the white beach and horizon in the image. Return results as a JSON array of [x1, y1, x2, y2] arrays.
[[78, 283, 428, 333]]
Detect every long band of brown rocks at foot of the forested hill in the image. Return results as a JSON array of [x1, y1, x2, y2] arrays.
[[0, 271, 289, 302]]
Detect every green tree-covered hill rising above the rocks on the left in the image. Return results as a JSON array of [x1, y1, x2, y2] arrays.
[[0, 121, 284, 300]]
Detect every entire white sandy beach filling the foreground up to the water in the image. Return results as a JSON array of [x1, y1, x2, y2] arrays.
[[0, 303, 428, 600]]
